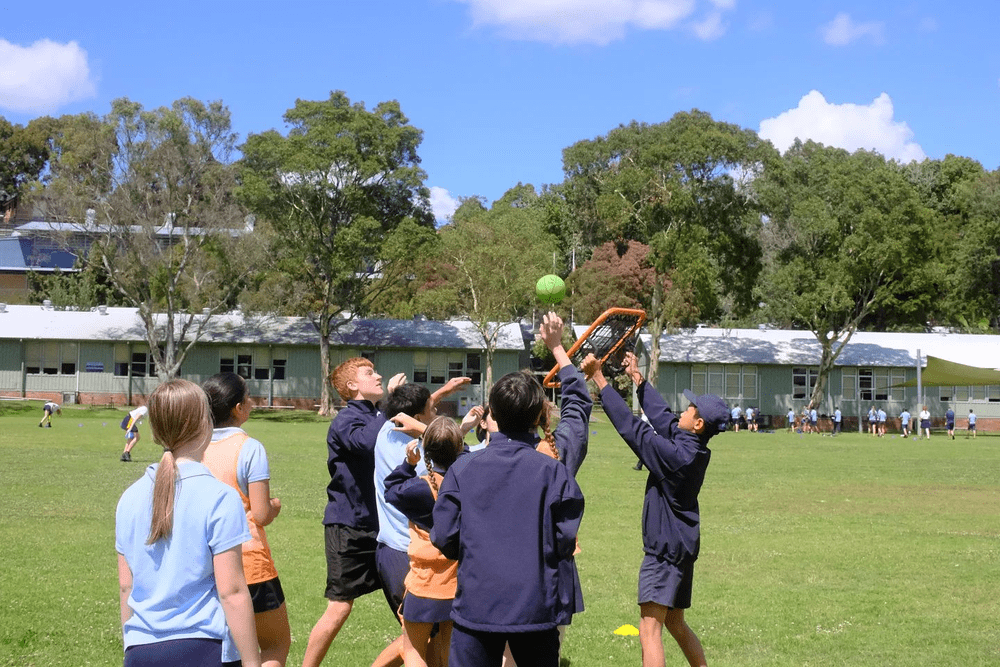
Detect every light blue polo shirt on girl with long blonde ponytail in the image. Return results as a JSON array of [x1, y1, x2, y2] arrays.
[[115, 461, 250, 648]]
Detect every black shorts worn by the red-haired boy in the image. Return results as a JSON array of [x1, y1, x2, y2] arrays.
[[324, 523, 382, 602]]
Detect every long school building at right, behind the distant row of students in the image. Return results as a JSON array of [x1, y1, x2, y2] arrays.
[[636, 327, 1000, 431]]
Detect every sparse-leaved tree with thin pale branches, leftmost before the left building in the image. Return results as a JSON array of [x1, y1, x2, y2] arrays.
[[37, 98, 258, 380]]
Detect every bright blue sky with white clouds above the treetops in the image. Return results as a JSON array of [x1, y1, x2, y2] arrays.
[[0, 0, 1000, 219]]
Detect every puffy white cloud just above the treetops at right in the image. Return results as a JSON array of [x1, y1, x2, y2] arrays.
[[758, 90, 927, 163]]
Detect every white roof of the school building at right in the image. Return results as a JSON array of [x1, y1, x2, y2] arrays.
[[642, 327, 1000, 368]]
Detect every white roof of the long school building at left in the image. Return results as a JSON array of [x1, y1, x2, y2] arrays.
[[0, 305, 524, 351]]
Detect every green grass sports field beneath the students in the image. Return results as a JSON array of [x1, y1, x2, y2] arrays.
[[0, 403, 1000, 667]]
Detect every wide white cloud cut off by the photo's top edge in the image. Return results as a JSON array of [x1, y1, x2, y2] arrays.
[[456, 0, 736, 46]]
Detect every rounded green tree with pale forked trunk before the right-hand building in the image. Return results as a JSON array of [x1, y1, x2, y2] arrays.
[[758, 141, 932, 406]]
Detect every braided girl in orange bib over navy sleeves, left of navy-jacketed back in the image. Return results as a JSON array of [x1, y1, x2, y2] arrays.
[[385, 417, 465, 667]]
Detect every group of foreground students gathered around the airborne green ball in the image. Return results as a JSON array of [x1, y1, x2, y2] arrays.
[[109, 313, 730, 667]]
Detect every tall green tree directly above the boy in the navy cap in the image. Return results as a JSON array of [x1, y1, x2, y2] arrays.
[[562, 110, 778, 381]]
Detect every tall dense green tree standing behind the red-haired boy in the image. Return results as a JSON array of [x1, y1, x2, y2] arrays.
[[241, 92, 434, 413]]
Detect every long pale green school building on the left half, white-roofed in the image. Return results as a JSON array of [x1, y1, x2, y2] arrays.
[[0, 304, 528, 415]]
